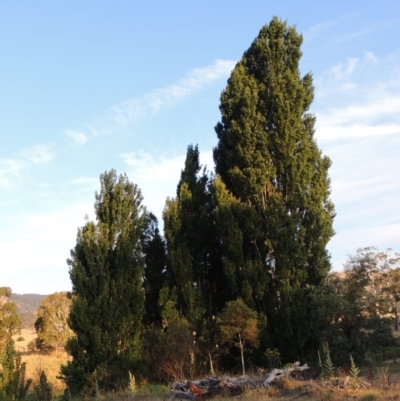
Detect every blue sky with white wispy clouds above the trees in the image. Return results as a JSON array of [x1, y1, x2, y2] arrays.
[[0, 0, 400, 294]]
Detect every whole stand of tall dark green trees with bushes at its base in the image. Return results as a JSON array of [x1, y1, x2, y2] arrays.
[[2, 18, 400, 393]]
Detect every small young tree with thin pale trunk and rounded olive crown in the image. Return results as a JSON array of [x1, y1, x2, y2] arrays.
[[217, 298, 258, 375]]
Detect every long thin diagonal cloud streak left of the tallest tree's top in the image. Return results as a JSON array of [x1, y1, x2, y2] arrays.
[[64, 60, 236, 144]]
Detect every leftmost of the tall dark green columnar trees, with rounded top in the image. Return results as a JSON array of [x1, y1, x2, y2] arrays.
[[62, 170, 147, 391]]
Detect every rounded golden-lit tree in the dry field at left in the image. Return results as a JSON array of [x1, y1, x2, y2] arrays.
[[35, 292, 73, 352]]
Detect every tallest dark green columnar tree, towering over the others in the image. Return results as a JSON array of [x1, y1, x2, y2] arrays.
[[214, 18, 334, 361]]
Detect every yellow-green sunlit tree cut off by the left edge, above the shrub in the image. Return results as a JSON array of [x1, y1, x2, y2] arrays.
[[0, 287, 21, 352]]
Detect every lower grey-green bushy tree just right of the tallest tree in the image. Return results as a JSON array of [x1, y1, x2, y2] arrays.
[[315, 248, 394, 366]]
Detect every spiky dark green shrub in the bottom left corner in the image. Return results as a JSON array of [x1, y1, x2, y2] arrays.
[[0, 338, 32, 401]]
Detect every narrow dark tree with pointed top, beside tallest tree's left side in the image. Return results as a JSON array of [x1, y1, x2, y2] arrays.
[[164, 146, 227, 325]]
